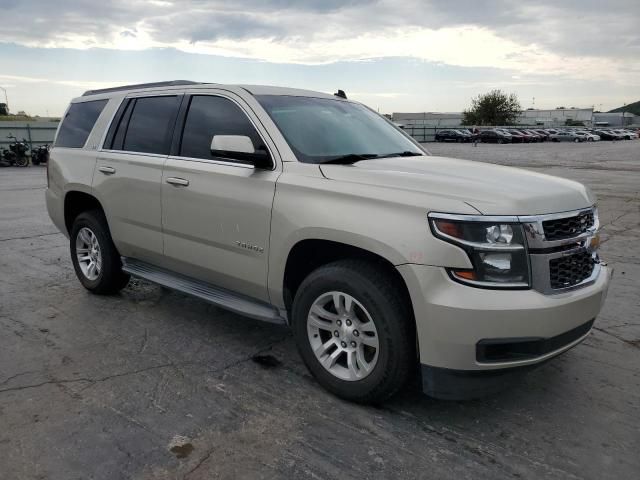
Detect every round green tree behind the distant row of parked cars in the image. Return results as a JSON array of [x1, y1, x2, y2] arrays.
[[462, 90, 522, 125]]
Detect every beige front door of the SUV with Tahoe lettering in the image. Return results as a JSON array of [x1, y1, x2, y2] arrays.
[[162, 90, 280, 300]]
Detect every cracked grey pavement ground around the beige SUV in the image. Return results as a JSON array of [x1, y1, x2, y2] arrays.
[[0, 141, 640, 480]]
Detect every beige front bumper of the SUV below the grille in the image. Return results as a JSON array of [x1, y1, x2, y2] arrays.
[[397, 264, 611, 398]]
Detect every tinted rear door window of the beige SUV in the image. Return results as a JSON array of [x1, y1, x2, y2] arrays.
[[120, 96, 178, 154]]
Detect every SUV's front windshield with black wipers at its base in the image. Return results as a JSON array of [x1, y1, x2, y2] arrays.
[[256, 95, 425, 163]]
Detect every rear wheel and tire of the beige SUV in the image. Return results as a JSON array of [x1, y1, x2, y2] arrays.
[[69, 210, 129, 295]]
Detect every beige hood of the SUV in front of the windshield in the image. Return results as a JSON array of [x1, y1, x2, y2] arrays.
[[320, 156, 595, 215]]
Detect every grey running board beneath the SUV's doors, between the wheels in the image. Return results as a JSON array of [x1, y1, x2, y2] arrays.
[[122, 257, 287, 324]]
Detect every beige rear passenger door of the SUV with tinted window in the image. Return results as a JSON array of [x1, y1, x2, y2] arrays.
[[93, 93, 182, 263]]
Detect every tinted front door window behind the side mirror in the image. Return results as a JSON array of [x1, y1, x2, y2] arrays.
[[180, 95, 266, 158]]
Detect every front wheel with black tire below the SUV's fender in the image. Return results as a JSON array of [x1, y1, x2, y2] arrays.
[[292, 260, 416, 404]]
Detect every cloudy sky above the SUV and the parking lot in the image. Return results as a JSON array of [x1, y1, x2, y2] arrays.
[[0, 0, 640, 115]]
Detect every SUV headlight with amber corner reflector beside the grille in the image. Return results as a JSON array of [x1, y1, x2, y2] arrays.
[[429, 213, 530, 289]]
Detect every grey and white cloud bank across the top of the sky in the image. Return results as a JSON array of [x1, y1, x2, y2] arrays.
[[0, 0, 640, 84]]
